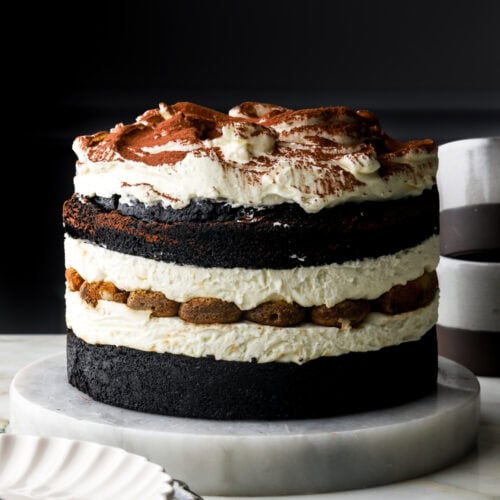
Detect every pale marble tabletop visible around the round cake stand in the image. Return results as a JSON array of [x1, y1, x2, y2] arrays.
[[0, 335, 500, 500]]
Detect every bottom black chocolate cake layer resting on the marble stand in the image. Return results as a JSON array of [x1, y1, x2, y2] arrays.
[[67, 328, 437, 420]]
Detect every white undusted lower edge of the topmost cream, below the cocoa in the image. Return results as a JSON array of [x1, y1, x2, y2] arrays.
[[74, 146, 437, 213]]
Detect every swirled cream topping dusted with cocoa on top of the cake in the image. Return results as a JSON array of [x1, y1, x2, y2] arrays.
[[74, 102, 437, 212]]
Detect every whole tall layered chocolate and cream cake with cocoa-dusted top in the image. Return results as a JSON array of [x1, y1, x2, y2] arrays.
[[63, 102, 439, 419]]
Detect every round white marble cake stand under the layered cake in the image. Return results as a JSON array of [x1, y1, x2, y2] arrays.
[[10, 354, 480, 496]]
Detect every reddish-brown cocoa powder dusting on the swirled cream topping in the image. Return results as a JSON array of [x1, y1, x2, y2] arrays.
[[77, 102, 437, 194]]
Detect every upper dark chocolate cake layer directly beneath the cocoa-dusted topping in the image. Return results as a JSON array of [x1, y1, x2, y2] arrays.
[[63, 189, 439, 269]]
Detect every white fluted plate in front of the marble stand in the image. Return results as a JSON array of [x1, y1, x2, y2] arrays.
[[0, 434, 174, 500]]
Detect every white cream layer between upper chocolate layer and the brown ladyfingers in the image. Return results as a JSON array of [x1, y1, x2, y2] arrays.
[[65, 236, 439, 310]]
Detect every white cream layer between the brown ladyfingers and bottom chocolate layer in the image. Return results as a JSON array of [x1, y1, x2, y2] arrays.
[[66, 291, 438, 364]]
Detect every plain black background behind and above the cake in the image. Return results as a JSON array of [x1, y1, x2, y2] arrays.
[[0, 0, 500, 333]]
